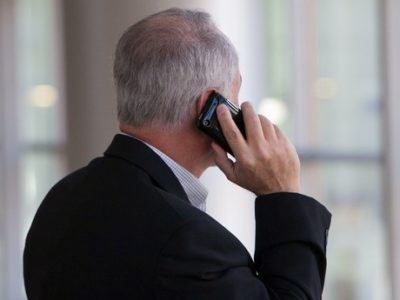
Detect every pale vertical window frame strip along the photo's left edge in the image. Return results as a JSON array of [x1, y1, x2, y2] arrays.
[[0, 0, 22, 299]]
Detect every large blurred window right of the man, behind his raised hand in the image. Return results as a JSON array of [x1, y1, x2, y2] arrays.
[[265, 0, 391, 300]]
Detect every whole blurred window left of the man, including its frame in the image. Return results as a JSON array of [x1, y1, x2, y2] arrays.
[[0, 0, 65, 300]]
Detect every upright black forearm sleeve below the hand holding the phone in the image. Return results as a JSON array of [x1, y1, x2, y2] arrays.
[[254, 193, 331, 299]]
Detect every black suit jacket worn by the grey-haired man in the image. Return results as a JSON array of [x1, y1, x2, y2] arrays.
[[24, 135, 330, 300]]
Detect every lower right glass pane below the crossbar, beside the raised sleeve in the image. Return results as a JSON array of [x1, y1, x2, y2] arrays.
[[303, 162, 390, 300]]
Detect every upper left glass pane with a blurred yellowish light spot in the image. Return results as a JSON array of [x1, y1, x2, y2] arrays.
[[16, 0, 63, 143]]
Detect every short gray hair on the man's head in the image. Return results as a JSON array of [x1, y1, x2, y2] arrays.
[[114, 8, 239, 128]]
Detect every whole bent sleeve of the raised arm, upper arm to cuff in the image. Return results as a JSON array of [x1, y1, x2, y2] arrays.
[[154, 194, 332, 300]]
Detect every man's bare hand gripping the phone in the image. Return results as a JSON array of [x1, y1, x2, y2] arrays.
[[211, 102, 300, 196]]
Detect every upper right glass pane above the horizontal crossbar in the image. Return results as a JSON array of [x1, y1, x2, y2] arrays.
[[315, 0, 382, 154]]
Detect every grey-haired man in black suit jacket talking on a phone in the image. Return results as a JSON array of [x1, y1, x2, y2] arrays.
[[24, 9, 330, 300]]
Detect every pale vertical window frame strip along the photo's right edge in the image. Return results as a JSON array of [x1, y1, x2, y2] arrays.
[[381, 0, 400, 299]]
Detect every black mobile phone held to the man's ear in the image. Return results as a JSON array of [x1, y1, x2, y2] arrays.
[[197, 92, 246, 155]]
